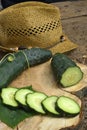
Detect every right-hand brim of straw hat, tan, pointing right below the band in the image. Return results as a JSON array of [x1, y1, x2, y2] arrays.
[[49, 34, 78, 54]]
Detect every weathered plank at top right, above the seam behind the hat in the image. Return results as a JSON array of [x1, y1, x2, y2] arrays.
[[53, 0, 87, 19]]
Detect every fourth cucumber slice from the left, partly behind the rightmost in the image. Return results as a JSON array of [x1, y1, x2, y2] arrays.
[[42, 96, 60, 115]]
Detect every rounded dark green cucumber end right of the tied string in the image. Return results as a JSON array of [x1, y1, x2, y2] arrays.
[[24, 48, 52, 67]]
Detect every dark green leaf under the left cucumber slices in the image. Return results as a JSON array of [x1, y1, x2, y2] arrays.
[[0, 100, 35, 128]]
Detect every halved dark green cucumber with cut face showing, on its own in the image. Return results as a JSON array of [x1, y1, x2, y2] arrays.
[[51, 53, 83, 87]]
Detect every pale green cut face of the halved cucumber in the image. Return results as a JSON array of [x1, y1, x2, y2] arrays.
[[60, 66, 83, 87]]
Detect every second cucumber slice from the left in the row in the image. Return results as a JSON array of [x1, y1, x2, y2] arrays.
[[15, 88, 33, 106]]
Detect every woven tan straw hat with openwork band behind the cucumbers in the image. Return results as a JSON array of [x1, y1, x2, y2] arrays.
[[0, 1, 77, 53]]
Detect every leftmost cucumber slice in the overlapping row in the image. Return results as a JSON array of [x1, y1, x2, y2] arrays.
[[1, 87, 18, 107]]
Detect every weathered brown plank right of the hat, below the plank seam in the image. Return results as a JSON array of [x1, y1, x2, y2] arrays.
[[62, 17, 87, 65]]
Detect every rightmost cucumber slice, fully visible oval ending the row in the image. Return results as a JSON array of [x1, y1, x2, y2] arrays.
[[57, 96, 80, 115]]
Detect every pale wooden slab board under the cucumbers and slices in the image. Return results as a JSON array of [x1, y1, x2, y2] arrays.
[[0, 61, 87, 130]]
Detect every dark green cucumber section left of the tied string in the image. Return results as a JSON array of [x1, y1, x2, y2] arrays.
[[0, 52, 27, 88]]
